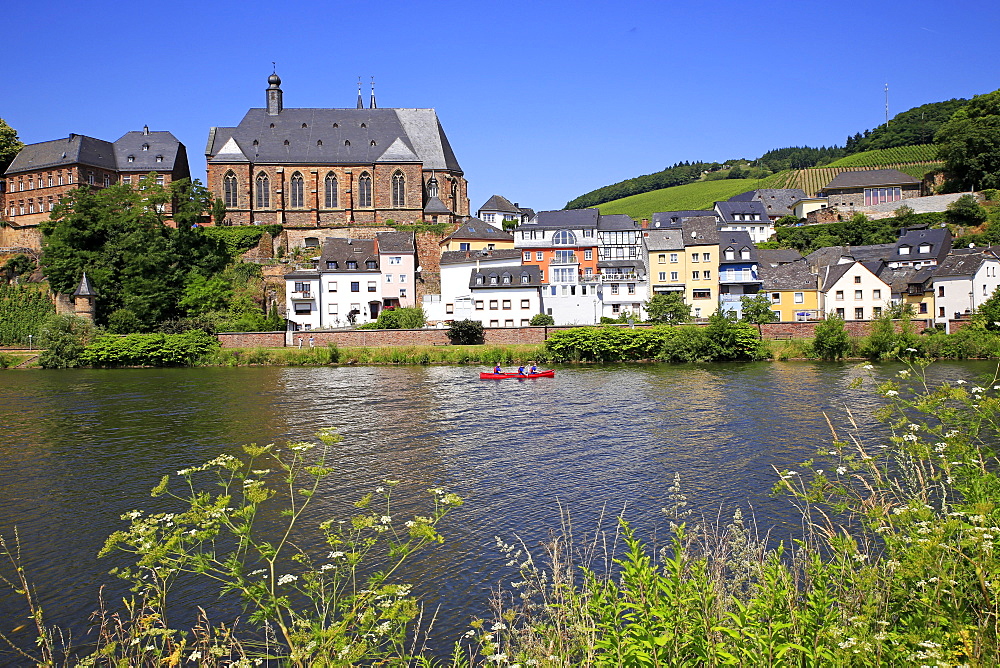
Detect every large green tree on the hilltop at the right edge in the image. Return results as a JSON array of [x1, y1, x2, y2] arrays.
[[934, 90, 1000, 192]]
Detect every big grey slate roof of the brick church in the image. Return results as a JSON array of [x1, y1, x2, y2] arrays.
[[205, 108, 462, 172]]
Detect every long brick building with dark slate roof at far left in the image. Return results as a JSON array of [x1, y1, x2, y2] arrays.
[[0, 127, 191, 228]]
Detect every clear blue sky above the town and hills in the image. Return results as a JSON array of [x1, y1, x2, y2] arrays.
[[0, 0, 1000, 210]]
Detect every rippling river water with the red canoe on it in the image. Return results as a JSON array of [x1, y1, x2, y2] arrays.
[[0, 362, 996, 663]]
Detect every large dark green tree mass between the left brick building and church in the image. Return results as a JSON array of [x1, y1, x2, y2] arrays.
[[41, 177, 228, 331]]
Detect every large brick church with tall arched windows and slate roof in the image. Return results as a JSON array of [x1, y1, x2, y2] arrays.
[[205, 74, 469, 228]]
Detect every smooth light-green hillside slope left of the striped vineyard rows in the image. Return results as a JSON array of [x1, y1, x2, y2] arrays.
[[597, 172, 788, 220]]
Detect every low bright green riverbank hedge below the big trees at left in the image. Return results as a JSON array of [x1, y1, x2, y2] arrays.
[[79, 329, 219, 367]]
